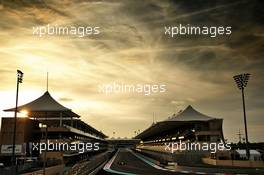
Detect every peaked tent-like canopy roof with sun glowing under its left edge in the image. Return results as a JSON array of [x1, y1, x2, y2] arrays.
[[4, 91, 80, 118]]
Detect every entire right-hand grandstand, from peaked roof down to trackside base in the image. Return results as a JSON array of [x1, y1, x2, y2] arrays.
[[135, 106, 225, 166]]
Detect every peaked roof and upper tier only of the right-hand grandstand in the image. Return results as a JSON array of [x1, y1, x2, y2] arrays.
[[135, 105, 224, 144]]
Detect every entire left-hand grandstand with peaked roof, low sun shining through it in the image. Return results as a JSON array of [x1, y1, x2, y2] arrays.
[[0, 91, 108, 166]]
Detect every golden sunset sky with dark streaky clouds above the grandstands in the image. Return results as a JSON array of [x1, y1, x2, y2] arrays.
[[0, 0, 264, 142]]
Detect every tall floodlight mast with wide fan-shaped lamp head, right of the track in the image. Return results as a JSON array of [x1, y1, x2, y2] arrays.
[[233, 73, 250, 159]]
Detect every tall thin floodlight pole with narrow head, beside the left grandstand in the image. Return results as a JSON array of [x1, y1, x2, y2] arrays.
[[12, 70, 24, 171]]
